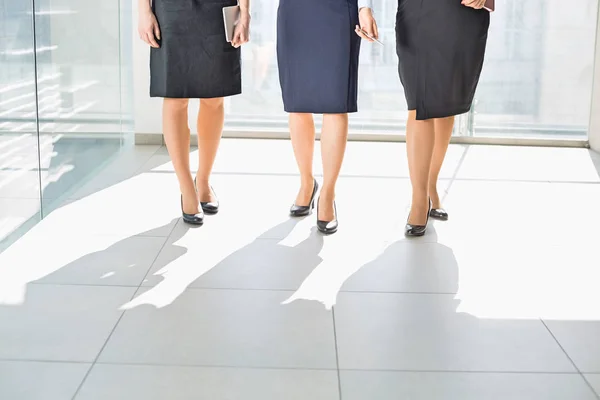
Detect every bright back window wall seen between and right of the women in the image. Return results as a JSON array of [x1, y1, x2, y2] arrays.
[[223, 0, 598, 139]]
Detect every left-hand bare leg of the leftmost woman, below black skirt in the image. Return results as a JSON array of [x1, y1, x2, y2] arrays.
[[163, 99, 199, 214]]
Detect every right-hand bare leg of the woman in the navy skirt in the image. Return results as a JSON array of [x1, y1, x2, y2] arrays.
[[318, 114, 348, 221]]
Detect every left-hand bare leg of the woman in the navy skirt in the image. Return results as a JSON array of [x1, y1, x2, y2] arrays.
[[290, 113, 315, 206]]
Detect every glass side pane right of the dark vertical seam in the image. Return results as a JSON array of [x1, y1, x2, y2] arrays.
[[35, 0, 129, 215]]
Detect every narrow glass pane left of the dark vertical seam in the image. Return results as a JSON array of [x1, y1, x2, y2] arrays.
[[0, 0, 40, 251]]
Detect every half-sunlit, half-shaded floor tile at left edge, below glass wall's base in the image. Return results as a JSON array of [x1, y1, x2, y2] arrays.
[[0, 229, 166, 294]]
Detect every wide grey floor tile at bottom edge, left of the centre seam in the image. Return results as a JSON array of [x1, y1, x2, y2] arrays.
[[76, 364, 339, 400]]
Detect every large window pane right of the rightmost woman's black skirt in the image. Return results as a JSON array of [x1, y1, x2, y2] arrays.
[[471, 0, 598, 139]]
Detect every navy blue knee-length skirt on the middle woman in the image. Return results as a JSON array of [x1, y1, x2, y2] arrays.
[[277, 0, 361, 114]]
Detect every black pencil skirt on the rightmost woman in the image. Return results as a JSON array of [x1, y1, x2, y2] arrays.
[[396, 0, 490, 120]]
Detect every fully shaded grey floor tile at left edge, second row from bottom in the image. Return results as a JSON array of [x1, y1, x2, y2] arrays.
[[0, 285, 135, 362]]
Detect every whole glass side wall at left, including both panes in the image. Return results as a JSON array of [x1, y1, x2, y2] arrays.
[[0, 0, 131, 251]]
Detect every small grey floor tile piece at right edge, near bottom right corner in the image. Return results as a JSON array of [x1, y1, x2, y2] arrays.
[[545, 320, 600, 373]]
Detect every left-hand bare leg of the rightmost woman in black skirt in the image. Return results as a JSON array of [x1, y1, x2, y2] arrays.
[[406, 110, 435, 225]]
